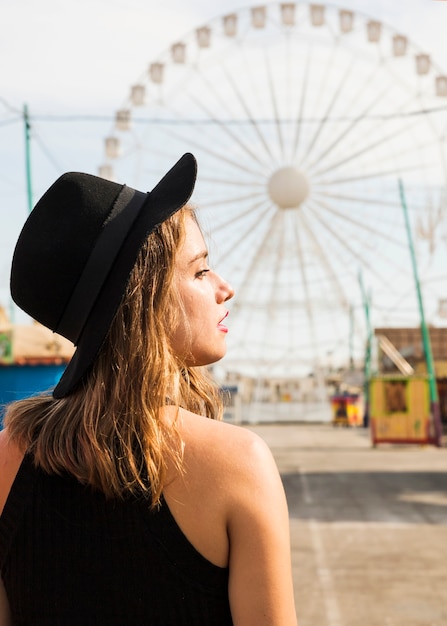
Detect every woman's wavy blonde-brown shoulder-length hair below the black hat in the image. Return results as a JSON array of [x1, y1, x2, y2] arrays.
[[4, 207, 222, 507]]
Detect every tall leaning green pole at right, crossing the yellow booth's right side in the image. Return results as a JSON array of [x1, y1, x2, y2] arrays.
[[399, 179, 442, 446]]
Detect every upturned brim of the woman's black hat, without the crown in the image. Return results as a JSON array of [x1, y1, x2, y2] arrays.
[[53, 153, 197, 398]]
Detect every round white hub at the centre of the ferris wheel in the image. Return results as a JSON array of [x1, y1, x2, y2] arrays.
[[268, 165, 310, 209]]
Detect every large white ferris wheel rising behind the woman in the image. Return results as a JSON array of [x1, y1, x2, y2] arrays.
[[99, 2, 447, 377]]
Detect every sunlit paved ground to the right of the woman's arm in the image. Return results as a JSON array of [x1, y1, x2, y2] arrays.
[[249, 424, 447, 626]]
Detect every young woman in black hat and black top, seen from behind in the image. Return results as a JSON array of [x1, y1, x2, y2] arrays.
[[0, 154, 296, 626]]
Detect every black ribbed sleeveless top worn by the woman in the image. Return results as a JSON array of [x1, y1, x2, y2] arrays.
[[0, 455, 233, 626]]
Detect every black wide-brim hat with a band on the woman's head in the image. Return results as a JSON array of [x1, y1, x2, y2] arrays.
[[11, 154, 197, 398]]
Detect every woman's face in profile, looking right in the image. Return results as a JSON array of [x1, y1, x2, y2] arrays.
[[171, 216, 234, 366]]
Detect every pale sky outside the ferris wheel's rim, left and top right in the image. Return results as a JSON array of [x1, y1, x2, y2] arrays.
[[0, 0, 447, 336]]
